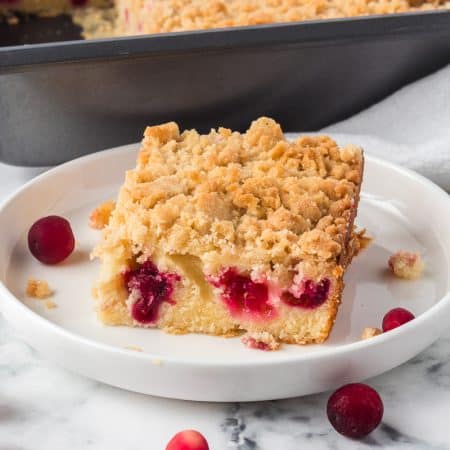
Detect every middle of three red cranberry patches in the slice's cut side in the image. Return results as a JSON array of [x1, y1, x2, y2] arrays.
[[210, 268, 277, 320]]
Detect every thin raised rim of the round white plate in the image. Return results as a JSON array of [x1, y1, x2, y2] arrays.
[[0, 142, 450, 368]]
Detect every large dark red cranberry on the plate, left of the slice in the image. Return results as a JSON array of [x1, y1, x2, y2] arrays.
[[28, 216, 75, 264]]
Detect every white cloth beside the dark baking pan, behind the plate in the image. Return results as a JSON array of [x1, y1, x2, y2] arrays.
[[322, 65, 450, 191]]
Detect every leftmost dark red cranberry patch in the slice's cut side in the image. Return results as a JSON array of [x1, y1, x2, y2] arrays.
[[123, 261, 181, 324]]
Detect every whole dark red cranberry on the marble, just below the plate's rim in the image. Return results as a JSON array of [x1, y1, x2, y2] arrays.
[[327, 383, 384, 439]]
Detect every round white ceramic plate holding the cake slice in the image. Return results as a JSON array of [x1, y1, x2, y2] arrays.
[[0, 145, 450, 401]]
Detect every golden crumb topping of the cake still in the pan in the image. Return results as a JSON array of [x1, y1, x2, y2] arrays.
[[116, 0, 450, 35]]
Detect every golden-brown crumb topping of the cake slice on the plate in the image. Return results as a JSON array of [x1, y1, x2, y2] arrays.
[[94, 117, 363, 273]]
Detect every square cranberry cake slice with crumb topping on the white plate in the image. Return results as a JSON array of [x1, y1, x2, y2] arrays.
[[93, 118, 363, 344]]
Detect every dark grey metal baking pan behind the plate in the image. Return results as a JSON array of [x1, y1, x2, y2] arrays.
[[0, 12, 450, 165]]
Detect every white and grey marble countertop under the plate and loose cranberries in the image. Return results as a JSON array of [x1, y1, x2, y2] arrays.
[[0, 164, 450, 450]]
